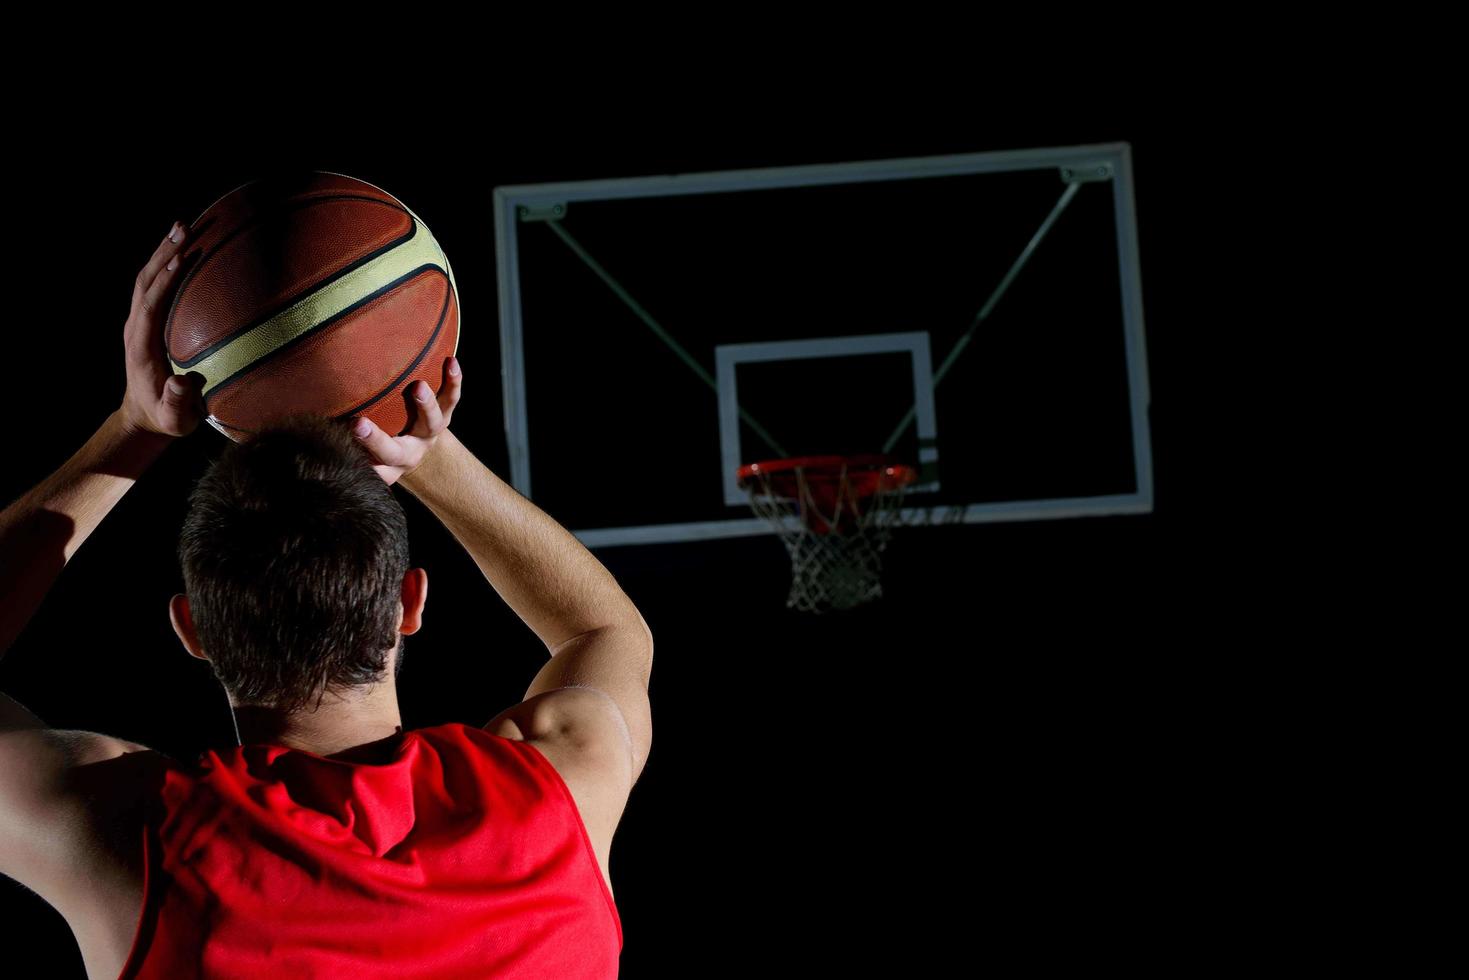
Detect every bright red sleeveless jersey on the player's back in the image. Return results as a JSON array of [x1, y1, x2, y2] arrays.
[[120, 723, 623, 980]]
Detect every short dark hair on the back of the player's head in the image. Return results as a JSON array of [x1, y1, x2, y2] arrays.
[[178, 413, 408, 713]]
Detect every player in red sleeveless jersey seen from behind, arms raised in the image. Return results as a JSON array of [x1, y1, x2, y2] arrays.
[[0, 218, 652, 980]]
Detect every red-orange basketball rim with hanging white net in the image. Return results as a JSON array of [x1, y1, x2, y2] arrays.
[[739, 455, 918, 613]]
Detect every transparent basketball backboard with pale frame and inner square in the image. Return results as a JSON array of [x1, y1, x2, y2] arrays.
[[494, 143, 1153, 547]]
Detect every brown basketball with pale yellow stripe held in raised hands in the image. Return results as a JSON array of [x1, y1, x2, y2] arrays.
[[163, 170, 458, 442]]
